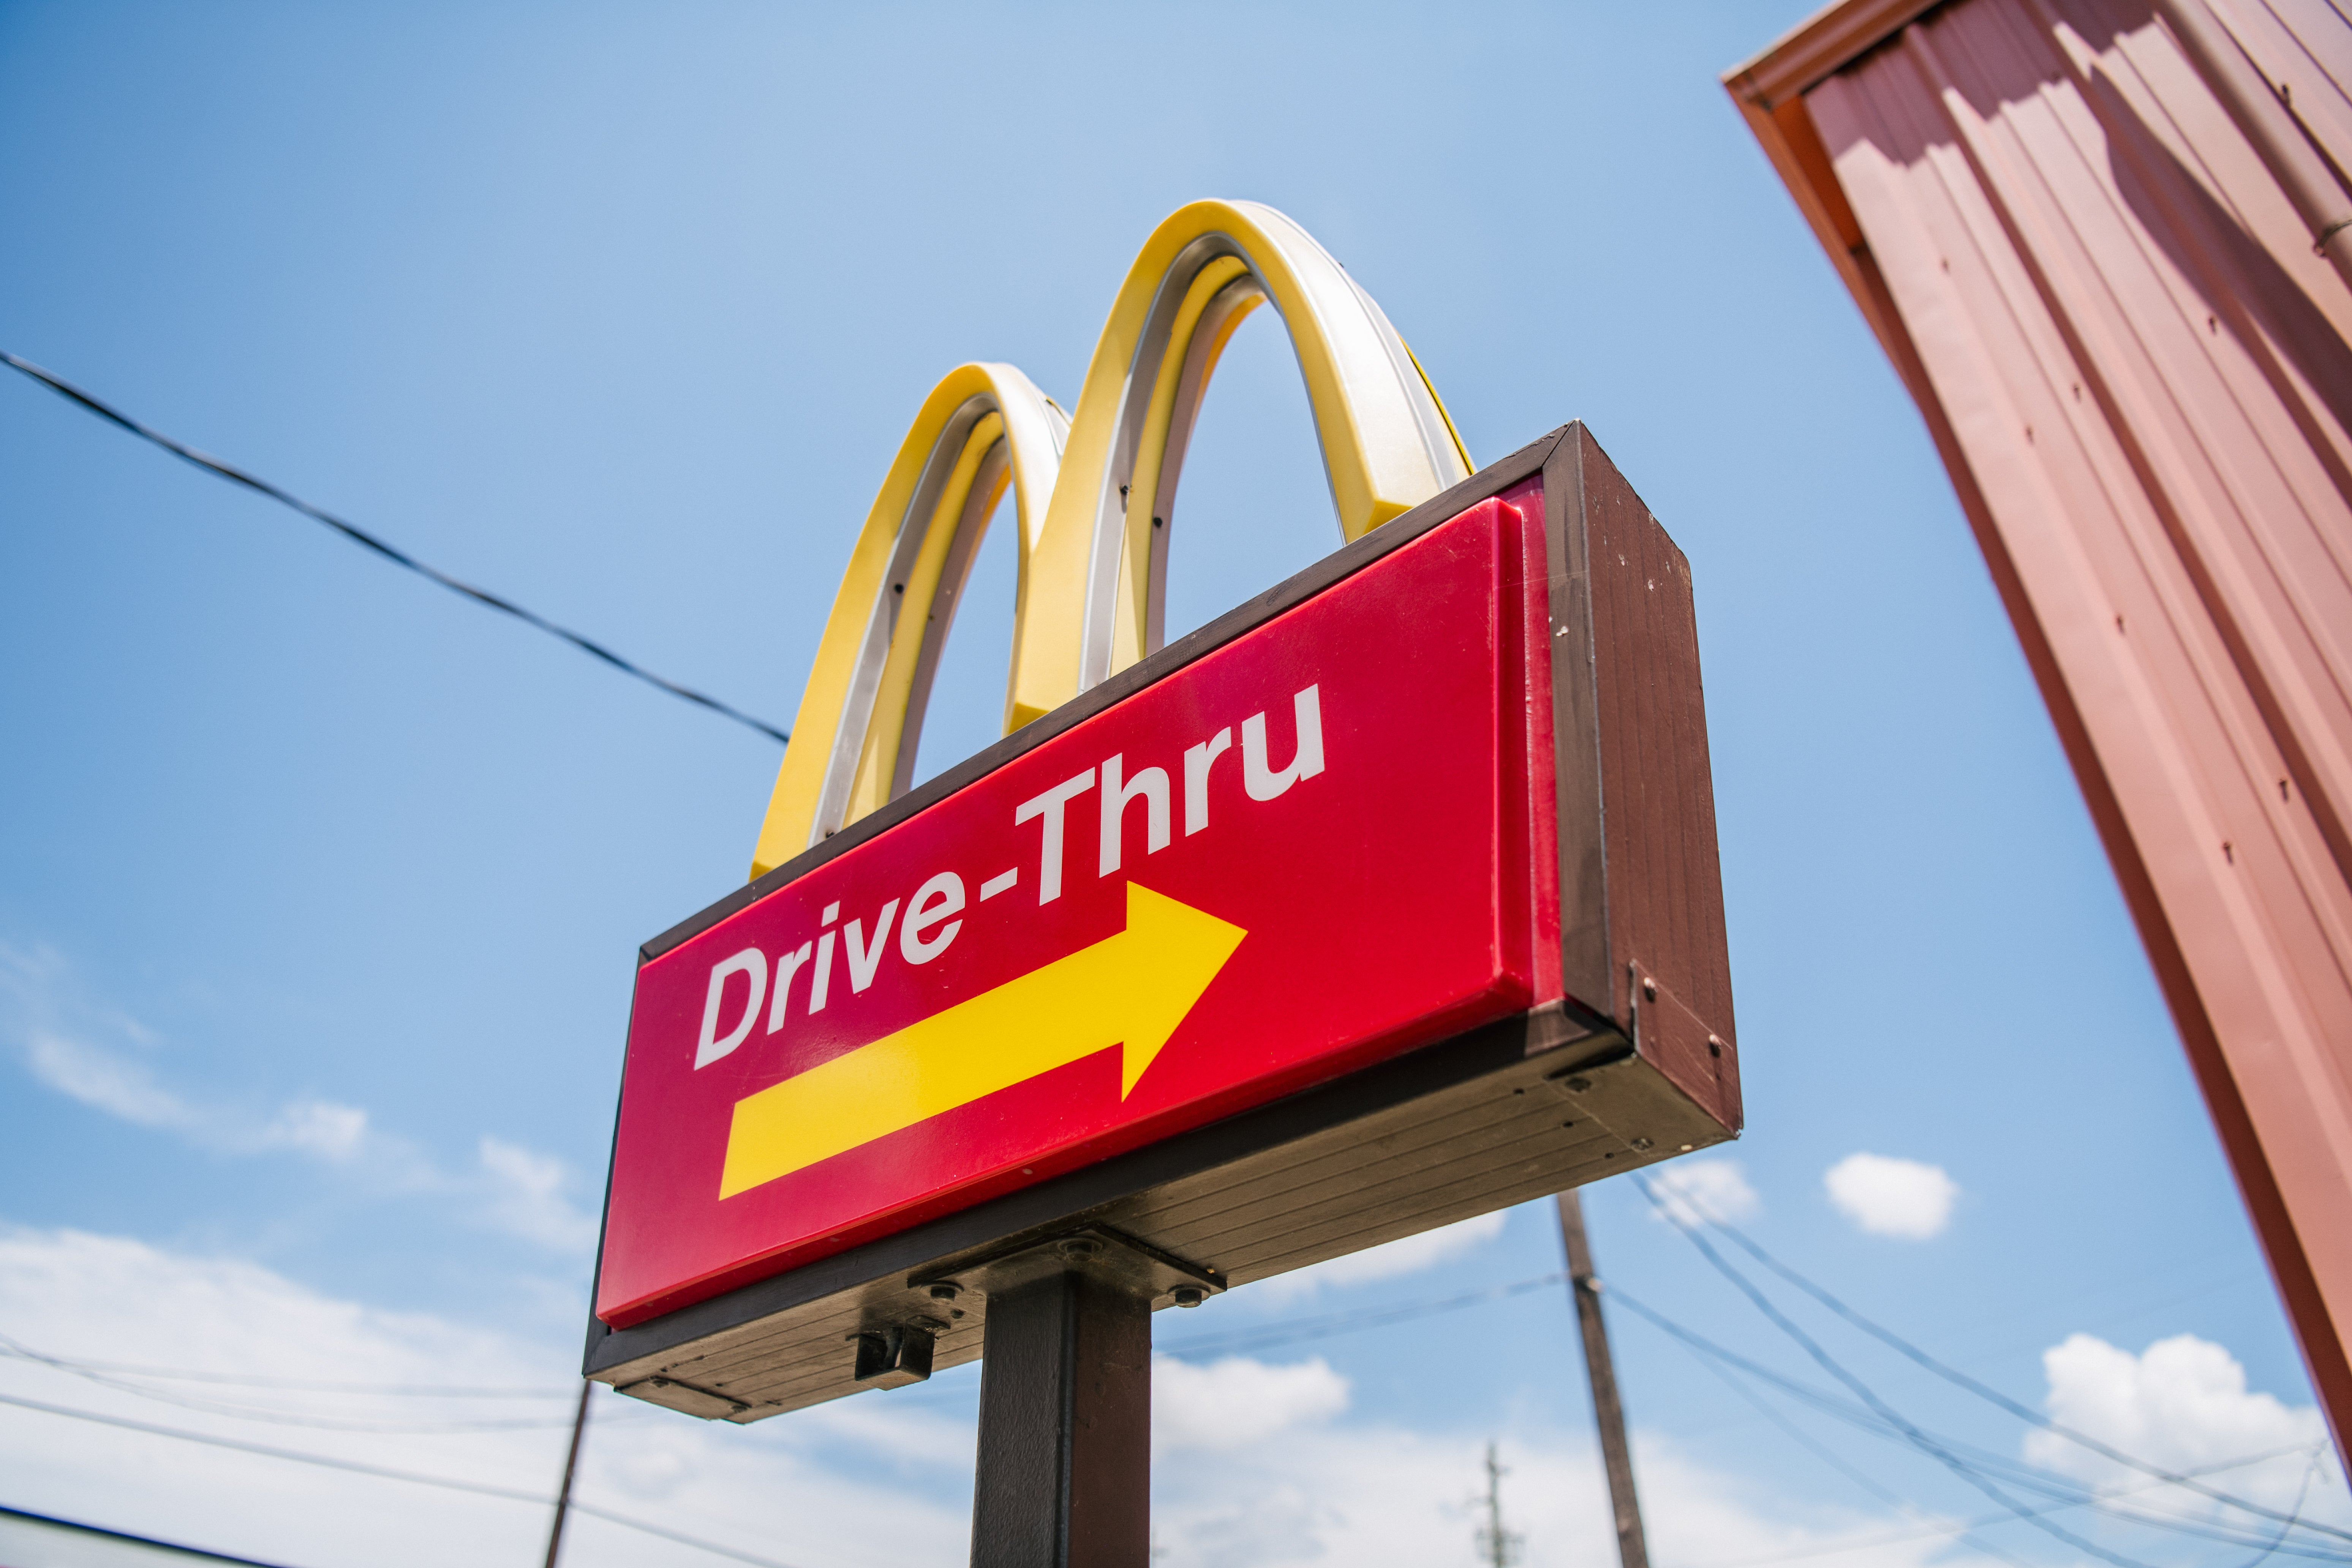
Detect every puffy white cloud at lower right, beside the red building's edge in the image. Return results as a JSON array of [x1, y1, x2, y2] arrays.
[[2025, 1333, 2352, 1523]]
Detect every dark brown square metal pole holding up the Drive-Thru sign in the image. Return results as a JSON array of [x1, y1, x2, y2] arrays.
[[971, 1236, 1152, 1568]]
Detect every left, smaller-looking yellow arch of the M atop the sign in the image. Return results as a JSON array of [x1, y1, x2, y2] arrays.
[[750, 364, 1070, 877]]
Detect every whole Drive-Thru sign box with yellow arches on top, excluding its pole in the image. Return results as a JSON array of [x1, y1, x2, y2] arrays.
[[586, 202, 1740, 1438]]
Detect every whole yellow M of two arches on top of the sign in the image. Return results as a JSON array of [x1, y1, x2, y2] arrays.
[[750, 202, 1470, 877]]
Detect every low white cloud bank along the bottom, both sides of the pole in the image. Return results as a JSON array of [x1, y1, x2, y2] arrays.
[[0, 1225, 2079, 1568]]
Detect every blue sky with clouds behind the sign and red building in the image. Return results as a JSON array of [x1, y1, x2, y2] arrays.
[[0, 0, 2347, 1568]]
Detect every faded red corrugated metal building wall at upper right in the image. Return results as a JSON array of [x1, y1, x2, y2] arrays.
[[1731, 0, 2352, 1439]]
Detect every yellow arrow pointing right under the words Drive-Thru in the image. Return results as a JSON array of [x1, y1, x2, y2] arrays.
[[720, 882, 1249, 1199]]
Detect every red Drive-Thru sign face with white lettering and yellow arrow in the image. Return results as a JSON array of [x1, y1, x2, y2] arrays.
[[595, 487, 1559, 1326]]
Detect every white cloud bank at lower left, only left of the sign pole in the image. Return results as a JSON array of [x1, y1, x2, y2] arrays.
[[0, 1225, 971, 1568]]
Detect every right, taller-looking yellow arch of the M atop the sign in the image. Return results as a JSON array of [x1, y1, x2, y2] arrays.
[[1009, 202, 1470, 726]]
